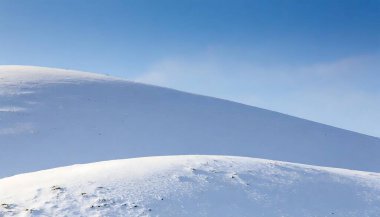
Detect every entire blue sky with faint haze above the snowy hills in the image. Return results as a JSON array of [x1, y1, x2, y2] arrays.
[[0, 0, 380, 137]]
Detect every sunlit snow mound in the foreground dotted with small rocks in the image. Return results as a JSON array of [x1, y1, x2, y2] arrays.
[[0, 156, 380, 217]]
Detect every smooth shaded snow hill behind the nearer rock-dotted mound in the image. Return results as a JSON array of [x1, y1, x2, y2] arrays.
[[0, 66, 380, 177]]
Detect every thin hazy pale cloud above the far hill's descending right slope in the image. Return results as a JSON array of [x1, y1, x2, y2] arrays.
[[135, 52, 380, 136]]
